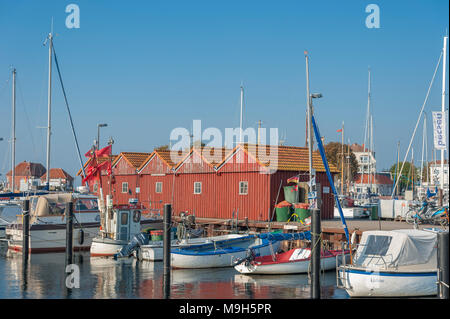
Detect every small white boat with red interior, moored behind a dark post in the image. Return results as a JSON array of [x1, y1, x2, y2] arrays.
[[234, 248, 350, 275]]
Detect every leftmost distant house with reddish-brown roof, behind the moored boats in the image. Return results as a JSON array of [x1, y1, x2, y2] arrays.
[[6, 161, 46, 192]]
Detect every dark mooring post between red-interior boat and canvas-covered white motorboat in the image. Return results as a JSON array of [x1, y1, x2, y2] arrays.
[[311, 209, 321, 299]]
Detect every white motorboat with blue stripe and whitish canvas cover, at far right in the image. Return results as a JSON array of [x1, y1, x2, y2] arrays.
[[337, 229, 437, 297]]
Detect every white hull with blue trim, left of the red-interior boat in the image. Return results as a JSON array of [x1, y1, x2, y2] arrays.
[[171, 241, 281, 269]]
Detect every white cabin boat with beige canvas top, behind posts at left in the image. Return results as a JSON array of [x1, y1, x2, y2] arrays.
[[6, 193, 100, 253]]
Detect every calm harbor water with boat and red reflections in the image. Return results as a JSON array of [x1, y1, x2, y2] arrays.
[[0, 243, 348, 299]]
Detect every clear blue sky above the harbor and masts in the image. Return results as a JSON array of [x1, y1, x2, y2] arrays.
[[0, 0, 449, 184]]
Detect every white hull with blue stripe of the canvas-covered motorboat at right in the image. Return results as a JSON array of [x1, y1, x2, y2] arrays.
[[338, 266, 437, 297]]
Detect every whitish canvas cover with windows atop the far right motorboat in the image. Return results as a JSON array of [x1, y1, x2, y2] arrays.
[[354, 229, 437, 268]]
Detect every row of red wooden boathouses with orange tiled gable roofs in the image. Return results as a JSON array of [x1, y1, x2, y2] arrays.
[[79, 144, 338, 221]]
